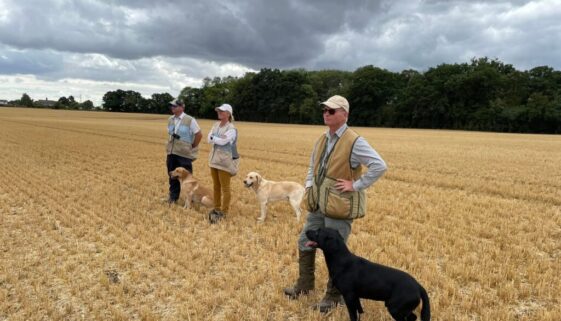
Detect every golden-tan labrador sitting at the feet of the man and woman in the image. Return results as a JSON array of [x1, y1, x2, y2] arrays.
[[169, 167, 214, 209]]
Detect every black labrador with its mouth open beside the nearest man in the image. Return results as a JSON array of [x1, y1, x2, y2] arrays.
[[306, 228, 430, 321]]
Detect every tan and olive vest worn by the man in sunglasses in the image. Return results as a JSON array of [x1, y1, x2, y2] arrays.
[[307, 128, 366, 219]]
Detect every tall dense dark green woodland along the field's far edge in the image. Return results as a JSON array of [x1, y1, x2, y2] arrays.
[[176, 58, 561, 133]]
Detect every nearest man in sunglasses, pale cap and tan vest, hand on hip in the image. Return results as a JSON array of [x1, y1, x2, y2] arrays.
[[284, 95, 387, 313]]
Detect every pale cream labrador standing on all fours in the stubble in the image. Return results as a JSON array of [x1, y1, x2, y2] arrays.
[[243, 172, 305, 222]]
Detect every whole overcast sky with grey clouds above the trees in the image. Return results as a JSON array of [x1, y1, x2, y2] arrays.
[[0, 0, 561, 105]]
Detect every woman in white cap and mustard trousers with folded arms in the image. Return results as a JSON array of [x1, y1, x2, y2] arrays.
[[208, 104, 239, 223]]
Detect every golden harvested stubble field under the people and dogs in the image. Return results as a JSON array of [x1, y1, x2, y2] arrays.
[[0, 108, 561, 321]]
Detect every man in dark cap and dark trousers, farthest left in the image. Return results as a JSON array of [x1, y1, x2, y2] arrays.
[[166, 99, 203, 204]]
